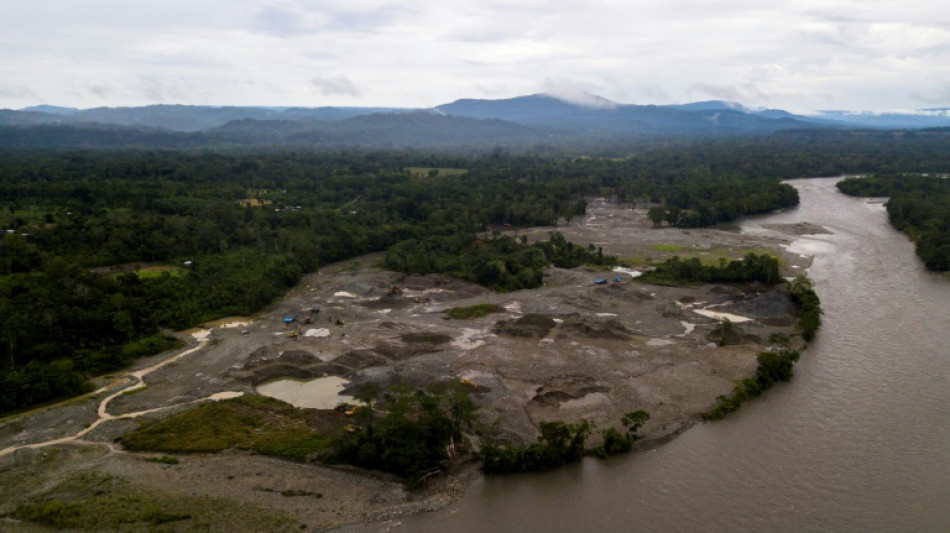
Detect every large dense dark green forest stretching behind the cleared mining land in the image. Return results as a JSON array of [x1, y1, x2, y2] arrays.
[[0, 132, 950, 412]]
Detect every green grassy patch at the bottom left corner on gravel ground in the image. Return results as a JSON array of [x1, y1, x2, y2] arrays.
[[4, 472, 300, 532]]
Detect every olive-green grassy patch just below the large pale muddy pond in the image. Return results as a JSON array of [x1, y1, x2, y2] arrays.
[[120, 396, 330, 461]]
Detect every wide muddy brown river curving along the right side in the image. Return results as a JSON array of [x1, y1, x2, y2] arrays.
[[360, 178, 950, 533]]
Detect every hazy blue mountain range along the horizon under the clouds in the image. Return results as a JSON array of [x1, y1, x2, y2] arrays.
[[0, 94, 950, 147]]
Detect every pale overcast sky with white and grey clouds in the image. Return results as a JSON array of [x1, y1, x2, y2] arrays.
[[0, 0, 950, 111]]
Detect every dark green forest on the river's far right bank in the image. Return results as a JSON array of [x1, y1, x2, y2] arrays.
[[838, 173, 950, 272]]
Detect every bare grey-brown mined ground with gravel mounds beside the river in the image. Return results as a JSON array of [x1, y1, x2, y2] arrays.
[[0, 204, 814, 529]]
